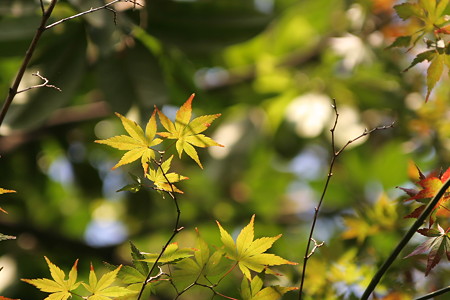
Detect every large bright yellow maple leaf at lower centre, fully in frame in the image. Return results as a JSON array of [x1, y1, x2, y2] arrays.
[[216, 215, 297, 279]]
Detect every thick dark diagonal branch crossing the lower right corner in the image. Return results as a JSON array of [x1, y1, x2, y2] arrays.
[[361, 178, 450, 300]]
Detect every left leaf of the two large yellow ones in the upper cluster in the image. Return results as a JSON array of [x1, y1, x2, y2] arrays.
[[95, 110, 162, 170]]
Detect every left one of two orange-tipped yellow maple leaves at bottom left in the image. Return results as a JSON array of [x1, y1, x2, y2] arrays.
[[21, 256, 80, 300]]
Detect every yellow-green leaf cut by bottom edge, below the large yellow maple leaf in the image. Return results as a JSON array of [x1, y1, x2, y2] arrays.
[[241, 276, 298, 300]]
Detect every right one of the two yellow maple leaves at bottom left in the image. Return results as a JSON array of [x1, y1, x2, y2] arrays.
[[82, 265, 136, 300]]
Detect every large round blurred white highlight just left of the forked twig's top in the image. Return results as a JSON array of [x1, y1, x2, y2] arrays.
[[286, 93, 332, 138]]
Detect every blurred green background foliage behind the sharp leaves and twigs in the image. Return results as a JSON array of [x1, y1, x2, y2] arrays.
[[0, 0, 450, 299]]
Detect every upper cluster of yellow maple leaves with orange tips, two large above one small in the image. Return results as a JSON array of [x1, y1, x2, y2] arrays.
[[96, 94, 223, 193]]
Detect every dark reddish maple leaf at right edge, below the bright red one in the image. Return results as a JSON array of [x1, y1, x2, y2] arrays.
[[405, 225, 450, 276]]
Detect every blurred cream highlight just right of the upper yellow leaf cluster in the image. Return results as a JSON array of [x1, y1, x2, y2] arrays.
[[208, 122, 244, 159]]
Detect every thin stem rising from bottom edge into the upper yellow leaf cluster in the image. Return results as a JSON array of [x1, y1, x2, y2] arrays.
[[137, 151, 184, 300]]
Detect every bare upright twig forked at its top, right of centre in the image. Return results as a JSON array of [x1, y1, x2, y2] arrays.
[[298, 99, 394, 300]]
